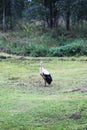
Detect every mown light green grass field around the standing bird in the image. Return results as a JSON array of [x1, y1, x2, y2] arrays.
[[0, 54, 87, 130]]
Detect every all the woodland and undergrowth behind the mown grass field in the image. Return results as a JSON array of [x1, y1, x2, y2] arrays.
[[0, 0, 87, 56]]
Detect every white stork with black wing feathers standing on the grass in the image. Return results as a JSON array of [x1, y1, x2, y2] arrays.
[[39, 61, 52, 86]]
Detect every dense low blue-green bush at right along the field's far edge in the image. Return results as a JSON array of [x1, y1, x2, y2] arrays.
[[49, 40, 87, 57]]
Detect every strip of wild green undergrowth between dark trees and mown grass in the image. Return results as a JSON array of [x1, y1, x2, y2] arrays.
[[0, 26, 87, 57]]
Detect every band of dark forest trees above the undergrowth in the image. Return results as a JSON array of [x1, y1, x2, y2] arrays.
[[0, 0, 87, 31]]
